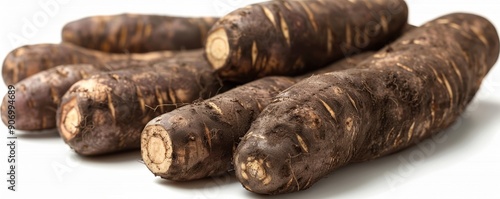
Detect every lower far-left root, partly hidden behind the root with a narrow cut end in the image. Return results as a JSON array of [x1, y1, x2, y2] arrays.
[[1, 50, 202, 131]]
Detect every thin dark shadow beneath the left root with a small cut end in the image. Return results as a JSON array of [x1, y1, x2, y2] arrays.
[[73, 150, 142, 164]]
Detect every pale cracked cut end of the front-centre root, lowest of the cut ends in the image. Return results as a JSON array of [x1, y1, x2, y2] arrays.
[[141, 125, 172, 175]]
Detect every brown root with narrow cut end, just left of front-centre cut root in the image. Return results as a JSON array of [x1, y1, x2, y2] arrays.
[[57, 53, 225, 155]]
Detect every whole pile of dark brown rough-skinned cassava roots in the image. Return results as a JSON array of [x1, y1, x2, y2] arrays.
[[1, 0, 499, 194]]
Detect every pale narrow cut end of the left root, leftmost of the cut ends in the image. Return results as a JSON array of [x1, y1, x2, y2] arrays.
[[61, 98, 81, 140]]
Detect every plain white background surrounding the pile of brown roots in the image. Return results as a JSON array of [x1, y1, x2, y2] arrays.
[[0, 0, 500, 199]]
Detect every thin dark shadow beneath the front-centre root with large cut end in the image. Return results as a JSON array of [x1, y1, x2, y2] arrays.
[[155, 173, 239, 190]]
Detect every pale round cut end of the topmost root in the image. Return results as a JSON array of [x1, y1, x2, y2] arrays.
[[205, 28, 231, 70]]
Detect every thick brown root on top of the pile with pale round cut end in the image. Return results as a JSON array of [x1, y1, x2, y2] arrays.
[[205, 0, 408, 82]]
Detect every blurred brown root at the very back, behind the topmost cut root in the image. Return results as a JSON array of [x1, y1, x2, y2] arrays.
[[62, 14, 218, 53]]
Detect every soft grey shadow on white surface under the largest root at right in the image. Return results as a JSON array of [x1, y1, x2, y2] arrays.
[[250, 100, 500, 199]]
